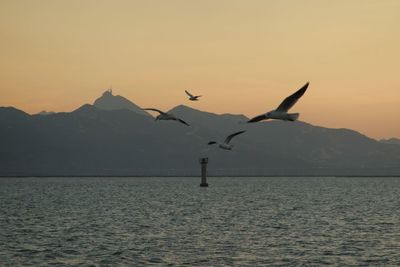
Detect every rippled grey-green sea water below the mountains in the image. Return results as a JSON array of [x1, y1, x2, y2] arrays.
[[0, 177, 400, 266]]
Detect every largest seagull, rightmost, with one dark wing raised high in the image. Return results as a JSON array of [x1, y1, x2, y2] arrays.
[[248, 82, 310, 123]]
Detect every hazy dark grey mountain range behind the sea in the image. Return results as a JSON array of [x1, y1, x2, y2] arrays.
[[0, 92, 400, 176]]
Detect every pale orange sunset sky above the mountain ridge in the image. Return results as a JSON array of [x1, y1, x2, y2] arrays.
[[0, 0, 400, 138]]
